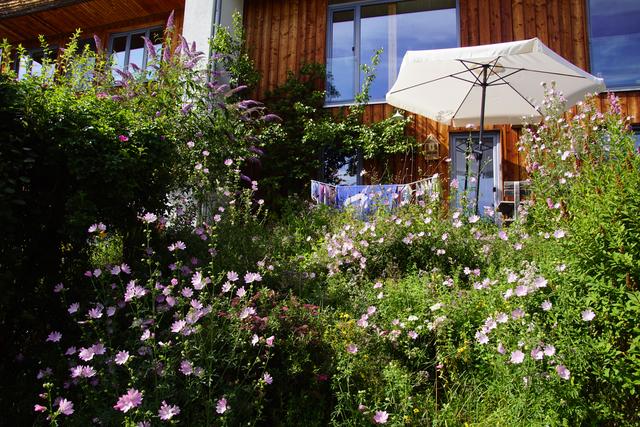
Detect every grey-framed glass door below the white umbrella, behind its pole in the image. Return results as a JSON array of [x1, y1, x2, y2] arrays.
[[449, 133, 502, 216]]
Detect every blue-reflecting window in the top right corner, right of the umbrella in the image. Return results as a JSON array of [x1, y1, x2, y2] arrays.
[[589, 0, 640, 89]]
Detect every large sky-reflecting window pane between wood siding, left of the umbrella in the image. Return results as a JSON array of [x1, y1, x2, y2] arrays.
[[327, 0, 458, 104]]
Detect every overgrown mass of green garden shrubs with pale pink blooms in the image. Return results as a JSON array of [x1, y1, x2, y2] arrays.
[[0, 15, 640, 426]]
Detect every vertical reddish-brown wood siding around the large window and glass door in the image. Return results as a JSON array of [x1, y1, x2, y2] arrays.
[[245, 0, 640, 186]]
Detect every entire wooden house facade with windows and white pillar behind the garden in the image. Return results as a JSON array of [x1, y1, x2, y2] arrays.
[[0, 0, 640, 206]]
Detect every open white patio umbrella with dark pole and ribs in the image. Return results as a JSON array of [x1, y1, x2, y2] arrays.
[[386, 38, 606, 214]]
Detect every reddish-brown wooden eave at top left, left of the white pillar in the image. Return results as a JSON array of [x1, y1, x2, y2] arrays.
[[0, 0, 184, 47]]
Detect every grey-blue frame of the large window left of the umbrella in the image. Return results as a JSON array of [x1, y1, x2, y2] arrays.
[[324, 0, 460, 107]]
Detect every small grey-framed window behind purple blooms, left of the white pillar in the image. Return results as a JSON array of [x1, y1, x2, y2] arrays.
[[109, 28, 163, 78]]
